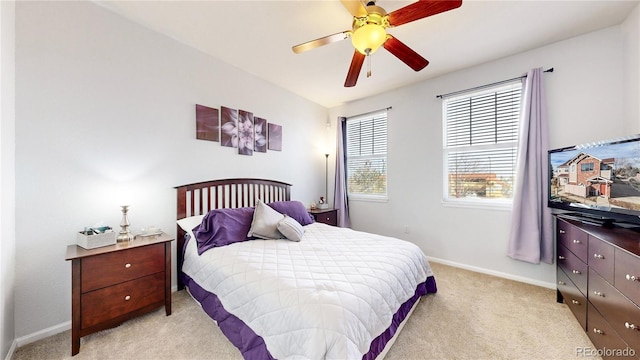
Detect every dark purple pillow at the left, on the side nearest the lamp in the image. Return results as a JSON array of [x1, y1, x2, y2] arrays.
[[193, 207, 255, 255]]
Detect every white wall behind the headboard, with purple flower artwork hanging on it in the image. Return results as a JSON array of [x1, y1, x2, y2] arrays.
[[15, 2, 327, 342]]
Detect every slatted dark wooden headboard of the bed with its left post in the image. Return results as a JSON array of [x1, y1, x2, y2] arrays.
[[176, 179, 291, 290]]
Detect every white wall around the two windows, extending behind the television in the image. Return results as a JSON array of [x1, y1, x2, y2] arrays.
[[330, 21, 640, 287]]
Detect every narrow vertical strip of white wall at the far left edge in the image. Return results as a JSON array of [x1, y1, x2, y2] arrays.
[[0, 1, 16, 358]]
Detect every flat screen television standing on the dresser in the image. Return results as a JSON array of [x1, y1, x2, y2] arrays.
[[548, 134, 640, 226]]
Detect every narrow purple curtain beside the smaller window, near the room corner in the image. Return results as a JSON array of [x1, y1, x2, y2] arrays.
[[333, 117, 351, 227]]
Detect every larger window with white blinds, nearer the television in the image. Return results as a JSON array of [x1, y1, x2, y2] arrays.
[[443, 81, 522, 204]]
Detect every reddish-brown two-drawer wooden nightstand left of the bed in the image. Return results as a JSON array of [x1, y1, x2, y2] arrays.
[[66, 233, 174, 356]]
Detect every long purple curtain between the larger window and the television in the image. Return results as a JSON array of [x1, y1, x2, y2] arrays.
[[508, 68, 553, 264]]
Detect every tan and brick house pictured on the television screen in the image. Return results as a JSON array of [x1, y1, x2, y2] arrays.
[[554, 152, 615, 199]]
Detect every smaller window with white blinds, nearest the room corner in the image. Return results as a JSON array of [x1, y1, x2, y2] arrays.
[[344, 110, 387, 199]]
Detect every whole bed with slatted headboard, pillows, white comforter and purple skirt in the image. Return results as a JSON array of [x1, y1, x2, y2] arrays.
[[176, 179, 437, 359]]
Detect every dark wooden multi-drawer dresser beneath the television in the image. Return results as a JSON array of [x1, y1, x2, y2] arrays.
[[556, 216, 640, 359]]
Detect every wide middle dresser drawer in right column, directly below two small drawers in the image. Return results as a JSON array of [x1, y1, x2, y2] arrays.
[[589, 271, 640, 354]]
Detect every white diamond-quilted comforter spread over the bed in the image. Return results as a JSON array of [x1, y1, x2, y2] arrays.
[[183, 223, 433, 359]]
